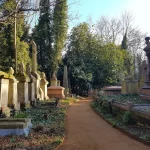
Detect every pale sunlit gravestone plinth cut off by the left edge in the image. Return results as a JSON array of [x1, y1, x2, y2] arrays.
[[0, 78, 10, 117]]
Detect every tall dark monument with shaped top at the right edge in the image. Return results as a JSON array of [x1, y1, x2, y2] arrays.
[[140, 37, 150, 100]]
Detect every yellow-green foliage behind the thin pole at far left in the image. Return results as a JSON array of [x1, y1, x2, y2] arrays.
[[0, 0, 31, 71]]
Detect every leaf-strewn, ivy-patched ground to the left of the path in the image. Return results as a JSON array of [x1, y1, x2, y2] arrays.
[[0, 98, 77, 150]]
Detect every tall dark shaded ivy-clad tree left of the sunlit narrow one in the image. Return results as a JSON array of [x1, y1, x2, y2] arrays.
[[33, 0, 54, 79]]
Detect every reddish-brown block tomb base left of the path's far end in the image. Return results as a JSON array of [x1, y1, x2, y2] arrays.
[[47, 86, 65, 98]]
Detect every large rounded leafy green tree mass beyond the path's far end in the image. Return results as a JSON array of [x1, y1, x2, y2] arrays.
[[58, 23, 124, 95]]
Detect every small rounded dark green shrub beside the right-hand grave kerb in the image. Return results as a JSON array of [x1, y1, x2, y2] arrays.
[[122, 111, 135, 125]]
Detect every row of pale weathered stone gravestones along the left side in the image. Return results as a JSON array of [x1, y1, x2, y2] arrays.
[[0, 63, 48, 117]]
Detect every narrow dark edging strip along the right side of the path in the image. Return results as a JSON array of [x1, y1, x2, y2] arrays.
[[90, 104, 150, 146]]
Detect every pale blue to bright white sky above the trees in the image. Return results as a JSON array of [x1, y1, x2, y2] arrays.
[[68, 0, 150, 36]]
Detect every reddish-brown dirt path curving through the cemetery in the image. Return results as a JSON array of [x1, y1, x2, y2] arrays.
[[57, 100, 150, 150]]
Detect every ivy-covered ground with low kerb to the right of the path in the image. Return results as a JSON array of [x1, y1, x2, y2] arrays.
[[91, 94, 150, 145]]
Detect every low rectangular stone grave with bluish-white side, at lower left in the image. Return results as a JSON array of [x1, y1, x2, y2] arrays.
[[0, 118, 32, 136]]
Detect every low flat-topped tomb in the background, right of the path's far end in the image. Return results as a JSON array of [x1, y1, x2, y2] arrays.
[[103, 86, 121, 95]]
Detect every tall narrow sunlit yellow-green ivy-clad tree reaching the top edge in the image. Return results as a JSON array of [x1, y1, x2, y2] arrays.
[[53, 0, 68, 71]]
